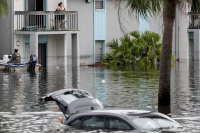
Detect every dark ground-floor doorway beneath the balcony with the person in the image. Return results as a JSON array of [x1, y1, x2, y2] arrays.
[[38, 43, 47, 68]]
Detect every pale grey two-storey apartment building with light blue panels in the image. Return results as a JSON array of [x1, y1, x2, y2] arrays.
[[0, 0, 191, 67]]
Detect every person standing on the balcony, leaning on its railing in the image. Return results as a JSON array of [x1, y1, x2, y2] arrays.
[[55, 2, 67, 30]]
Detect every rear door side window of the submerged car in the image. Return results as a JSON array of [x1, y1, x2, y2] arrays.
[[82, 116, 105, 128]]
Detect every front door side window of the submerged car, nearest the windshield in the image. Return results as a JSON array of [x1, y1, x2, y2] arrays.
[[109, 118, 131, 130]]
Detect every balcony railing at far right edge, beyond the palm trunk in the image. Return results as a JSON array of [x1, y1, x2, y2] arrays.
[[188, 12, 200, 29]]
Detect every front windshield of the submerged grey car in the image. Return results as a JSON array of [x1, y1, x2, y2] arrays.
[[132, 116, 180, 131]]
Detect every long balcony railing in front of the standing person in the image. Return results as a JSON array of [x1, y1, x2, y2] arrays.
[[15, 11, 78, 31]]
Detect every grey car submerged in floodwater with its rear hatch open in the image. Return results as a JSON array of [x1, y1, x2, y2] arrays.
[[42, 89, 180, 131]]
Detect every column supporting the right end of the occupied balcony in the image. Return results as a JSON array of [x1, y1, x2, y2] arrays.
[[71, 33, 80, 66]]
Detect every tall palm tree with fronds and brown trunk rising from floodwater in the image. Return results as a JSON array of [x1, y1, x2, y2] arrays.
[[115, 0, 200, 106]]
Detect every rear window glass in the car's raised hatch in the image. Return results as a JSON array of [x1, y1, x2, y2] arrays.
[[60, 90, 93, 104]]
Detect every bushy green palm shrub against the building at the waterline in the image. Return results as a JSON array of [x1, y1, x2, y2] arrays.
[[102, 31, 162, 65]]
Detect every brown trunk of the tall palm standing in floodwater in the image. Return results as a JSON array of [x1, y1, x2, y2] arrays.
[[158, 0, 177, 106]]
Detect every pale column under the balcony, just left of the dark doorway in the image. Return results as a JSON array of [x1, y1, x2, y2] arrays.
[[30, 32, 38, 57]]
